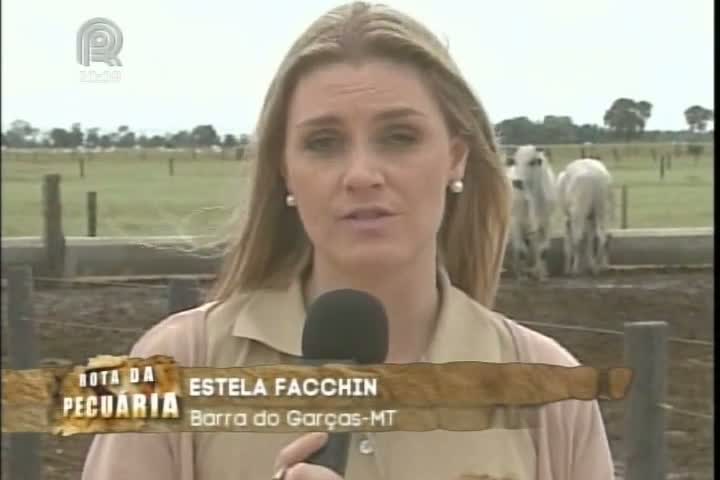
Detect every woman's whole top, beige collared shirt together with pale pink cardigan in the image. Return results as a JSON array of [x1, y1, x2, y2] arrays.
[[83, 275, 612, 480]]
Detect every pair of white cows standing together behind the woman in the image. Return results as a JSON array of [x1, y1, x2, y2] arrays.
[[505, 145, 615, 280]]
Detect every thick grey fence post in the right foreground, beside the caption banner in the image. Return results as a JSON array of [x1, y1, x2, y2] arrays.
[[623, 322, 667, 480]]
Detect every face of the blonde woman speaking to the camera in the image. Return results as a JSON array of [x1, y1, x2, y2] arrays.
[[284, 60, 467, 269]]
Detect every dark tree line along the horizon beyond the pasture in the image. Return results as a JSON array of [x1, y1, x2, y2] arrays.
[[0, 98, 714, 148]]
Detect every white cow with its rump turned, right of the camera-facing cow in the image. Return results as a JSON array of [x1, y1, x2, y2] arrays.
[[557, 158, 614, 275]]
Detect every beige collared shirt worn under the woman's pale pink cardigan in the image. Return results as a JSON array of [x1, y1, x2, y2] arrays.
[[195, 275, 536, 480]]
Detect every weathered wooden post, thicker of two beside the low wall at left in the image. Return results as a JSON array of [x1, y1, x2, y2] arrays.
[[43, 173, 65, 277]]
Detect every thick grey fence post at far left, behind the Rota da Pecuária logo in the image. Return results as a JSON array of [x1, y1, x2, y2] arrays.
[[7, 266, 42, 480]]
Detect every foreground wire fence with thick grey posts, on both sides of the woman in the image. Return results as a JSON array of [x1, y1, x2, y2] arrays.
[[2, 266, 714, 480]]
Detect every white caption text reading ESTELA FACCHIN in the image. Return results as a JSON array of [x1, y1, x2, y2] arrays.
[[188, 377, 378, 397]]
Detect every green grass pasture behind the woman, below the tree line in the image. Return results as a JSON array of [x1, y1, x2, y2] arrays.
[[2, 144, 713, 237]]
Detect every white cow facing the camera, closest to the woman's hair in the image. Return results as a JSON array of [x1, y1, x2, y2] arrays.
[[507, 145, 557, 280]]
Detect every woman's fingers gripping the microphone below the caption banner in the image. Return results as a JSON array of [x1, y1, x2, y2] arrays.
[[273, 432, 343, 480]]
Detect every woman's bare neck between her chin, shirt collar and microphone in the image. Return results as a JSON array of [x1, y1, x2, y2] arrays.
[[304, 256, 440, 363]]
